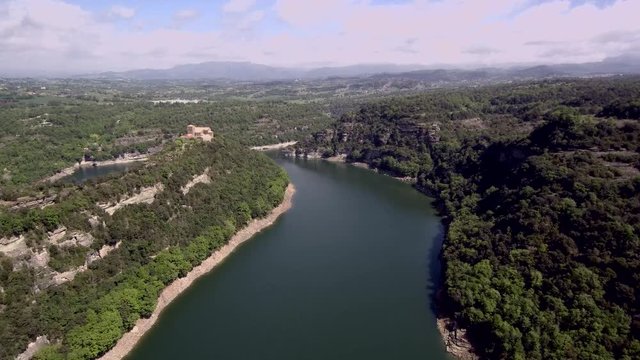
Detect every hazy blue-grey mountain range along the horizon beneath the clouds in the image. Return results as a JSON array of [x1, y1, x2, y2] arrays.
[[79, 56, 640, 82]]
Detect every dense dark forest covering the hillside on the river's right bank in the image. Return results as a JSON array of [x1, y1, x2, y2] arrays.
[[295, 77, 640, 359]]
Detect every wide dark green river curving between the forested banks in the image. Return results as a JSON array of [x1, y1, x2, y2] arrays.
[[128, 159, 448, 360]]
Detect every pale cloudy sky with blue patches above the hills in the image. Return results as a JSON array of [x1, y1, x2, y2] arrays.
[[0, 0, 640, 74]]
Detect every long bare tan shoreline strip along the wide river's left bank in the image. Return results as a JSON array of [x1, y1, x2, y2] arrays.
[[98, 183, 296, 360]]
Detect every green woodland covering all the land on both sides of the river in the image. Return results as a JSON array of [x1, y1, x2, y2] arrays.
[[0, 77, 640, 359]]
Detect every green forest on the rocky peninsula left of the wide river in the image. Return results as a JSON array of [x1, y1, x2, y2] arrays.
[[0, 139, 288, 359]]
